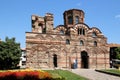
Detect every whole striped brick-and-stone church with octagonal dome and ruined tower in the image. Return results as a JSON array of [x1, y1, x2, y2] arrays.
[[26, 9, 109, 69]]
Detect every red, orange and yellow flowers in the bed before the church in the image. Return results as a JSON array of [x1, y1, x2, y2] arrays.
[[0, 70, 51, 80]]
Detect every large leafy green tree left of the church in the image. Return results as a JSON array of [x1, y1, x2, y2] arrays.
[[0, 37, 21, 69]]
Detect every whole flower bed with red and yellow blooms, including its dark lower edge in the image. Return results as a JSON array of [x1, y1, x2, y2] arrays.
[[0, 70, 51, 80]]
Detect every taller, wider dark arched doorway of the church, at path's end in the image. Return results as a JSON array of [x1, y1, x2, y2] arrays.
[[81, 51, 89, 68]]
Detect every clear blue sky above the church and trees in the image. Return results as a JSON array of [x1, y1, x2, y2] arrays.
[[0, 0, 120, 48]]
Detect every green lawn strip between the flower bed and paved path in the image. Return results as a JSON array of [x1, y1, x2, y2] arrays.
[[45, 70, 88, 80]]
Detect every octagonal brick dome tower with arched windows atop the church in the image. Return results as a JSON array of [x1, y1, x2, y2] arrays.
[[63, 9, 84, 28]]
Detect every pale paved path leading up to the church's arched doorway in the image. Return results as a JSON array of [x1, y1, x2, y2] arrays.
[[72, 69, 120, 80]]
